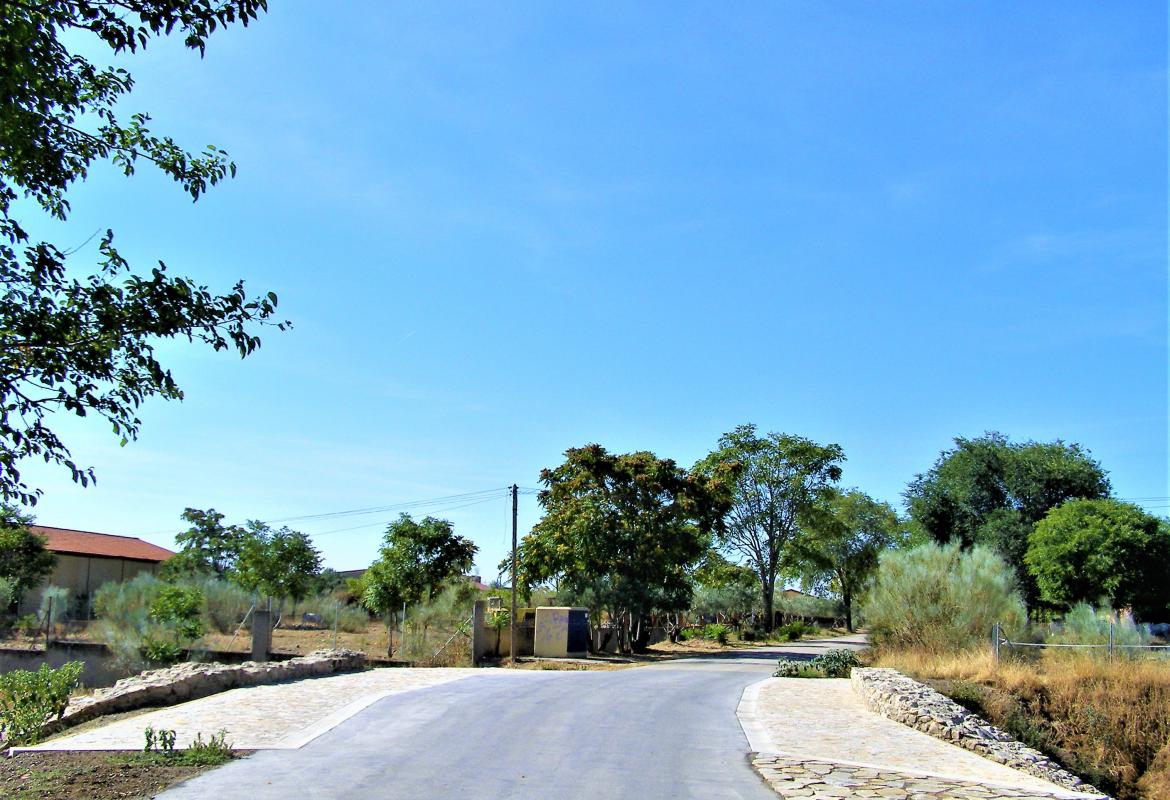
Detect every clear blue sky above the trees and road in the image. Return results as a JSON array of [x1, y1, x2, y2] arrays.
[[16, 1, 1170, 577]]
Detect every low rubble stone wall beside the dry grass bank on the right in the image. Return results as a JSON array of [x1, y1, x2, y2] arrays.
[[852, 667, 1102, 796]]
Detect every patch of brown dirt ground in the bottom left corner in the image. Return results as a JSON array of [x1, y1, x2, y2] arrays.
[[0, 751, 243, 800]]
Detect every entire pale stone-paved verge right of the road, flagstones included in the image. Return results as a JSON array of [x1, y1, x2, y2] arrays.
[[738, 678, 1090, 800]]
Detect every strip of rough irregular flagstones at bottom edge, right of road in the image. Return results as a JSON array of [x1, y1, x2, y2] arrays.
[[752, 753, 1090, 800]]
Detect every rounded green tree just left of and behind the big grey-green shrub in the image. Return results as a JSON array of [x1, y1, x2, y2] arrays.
[[792, 489, 907, 633]]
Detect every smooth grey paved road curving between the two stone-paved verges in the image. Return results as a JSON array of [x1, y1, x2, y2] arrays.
[[159, 643, 865, 800]]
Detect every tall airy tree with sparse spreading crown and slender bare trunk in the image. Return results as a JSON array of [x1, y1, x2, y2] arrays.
[[695, 425, 845, 630]]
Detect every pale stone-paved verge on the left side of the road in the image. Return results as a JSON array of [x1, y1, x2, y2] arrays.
[[33, 668, 531, 750]]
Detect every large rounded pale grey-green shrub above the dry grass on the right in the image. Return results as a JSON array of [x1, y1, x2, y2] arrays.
[[865, 543, 1026, 651]]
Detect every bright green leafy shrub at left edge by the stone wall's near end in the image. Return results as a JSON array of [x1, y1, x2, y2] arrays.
[[0, 661, 83, 745]]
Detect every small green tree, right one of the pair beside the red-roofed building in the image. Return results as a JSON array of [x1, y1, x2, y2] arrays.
[[232, 520, 321, 611]]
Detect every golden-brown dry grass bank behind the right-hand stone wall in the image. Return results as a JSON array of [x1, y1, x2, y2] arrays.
[[875, 648, 1170, 800]]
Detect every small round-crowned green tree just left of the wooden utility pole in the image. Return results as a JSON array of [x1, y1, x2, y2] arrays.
[[360, 513, 479, 656]]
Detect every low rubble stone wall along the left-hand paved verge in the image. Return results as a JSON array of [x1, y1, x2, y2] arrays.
[[34, 650, 365, 733]]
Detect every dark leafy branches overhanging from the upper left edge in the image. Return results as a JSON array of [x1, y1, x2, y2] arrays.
[[0, 0, 287, 504]]
